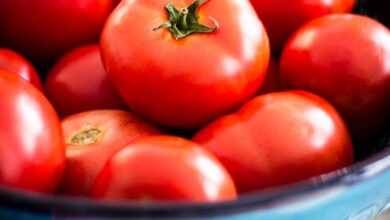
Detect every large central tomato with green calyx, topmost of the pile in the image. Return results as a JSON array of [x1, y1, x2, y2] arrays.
[[101, 0, 269, 129]]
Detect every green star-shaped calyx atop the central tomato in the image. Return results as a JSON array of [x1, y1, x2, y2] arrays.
[[153, 0, 218, 40]]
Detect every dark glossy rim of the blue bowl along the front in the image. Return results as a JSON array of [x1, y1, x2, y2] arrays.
[[0, 143, 390, 218]]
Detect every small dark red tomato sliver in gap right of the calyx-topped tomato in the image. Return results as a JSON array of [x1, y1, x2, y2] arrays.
[[259, 59, 282, 94]]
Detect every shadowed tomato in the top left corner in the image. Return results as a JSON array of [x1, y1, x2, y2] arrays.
[[0, 0, 113, 62]]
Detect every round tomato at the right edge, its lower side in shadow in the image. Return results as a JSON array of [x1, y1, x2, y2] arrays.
[[280, 15, 390, 139]]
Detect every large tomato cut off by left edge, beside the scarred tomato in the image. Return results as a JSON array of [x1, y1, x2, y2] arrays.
[[0, 70, 65, 192]]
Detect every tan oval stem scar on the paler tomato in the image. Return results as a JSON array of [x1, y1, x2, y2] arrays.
[[66, 125, 104, 146]]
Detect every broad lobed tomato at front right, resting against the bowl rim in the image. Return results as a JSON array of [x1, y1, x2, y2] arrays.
[[194, 91, 353, 192]]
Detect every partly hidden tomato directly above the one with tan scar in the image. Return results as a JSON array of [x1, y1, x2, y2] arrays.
[[45, 45, 125, 115]]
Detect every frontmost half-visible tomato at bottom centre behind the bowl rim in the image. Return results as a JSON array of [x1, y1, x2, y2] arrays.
[[93, 136, 236, 202]]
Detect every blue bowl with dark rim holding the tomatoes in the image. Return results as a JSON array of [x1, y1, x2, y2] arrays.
[[0, 0, 390, 220]]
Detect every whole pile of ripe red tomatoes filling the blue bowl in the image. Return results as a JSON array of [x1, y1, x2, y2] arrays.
[[0, 0, 390, 202]]
